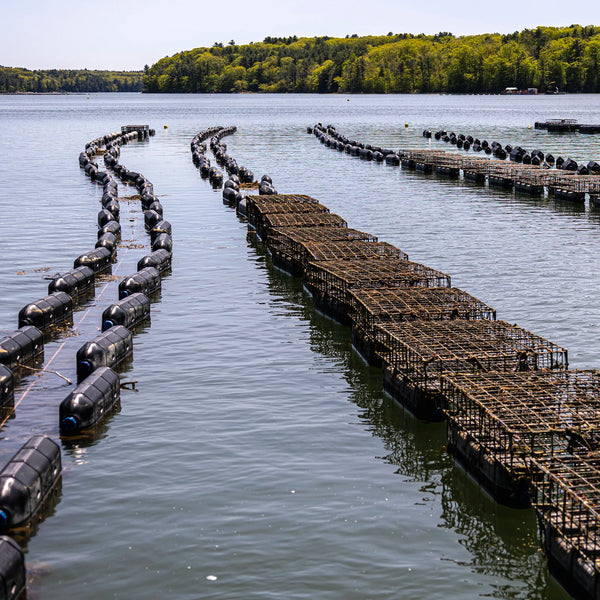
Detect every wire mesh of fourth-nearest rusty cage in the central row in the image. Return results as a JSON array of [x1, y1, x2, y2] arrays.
[[349, 287, 496, 333]]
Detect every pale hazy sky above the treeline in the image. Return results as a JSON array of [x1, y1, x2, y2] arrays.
[[0, 0, 600, 70]]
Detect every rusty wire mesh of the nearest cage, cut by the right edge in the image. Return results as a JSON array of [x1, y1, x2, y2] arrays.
[[533, 452, 600, 573]]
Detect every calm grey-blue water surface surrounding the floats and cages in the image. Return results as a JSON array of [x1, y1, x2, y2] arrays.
[[0, 94, 600, 600]]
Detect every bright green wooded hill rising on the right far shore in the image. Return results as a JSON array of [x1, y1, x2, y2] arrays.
[[144, 25, 600, 93]]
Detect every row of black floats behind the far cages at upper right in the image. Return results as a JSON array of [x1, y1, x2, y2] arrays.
[[423, 129, 600, 175]]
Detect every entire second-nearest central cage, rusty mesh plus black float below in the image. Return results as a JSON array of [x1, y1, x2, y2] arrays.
[[442, 370, 600, 503]]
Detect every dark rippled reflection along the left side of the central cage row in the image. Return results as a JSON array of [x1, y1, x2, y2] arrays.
[[248, 227, 568, 600]]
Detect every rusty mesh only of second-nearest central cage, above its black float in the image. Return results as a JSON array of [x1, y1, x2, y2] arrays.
[[442, 370, 600, 468]]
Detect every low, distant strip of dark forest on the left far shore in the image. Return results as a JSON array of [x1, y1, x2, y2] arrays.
[[0, 66, 144, 94]]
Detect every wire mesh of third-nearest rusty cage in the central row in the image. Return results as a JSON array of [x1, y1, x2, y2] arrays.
[[375, 319, 567, 390]]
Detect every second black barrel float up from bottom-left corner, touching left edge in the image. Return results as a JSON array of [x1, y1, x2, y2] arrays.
[[0, 434, 61, 531]]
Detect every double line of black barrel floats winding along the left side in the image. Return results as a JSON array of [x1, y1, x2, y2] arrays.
[[0, 126, 172, 600]]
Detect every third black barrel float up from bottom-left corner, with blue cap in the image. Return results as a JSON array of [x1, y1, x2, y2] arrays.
[[58, 367, 121, 435]]
